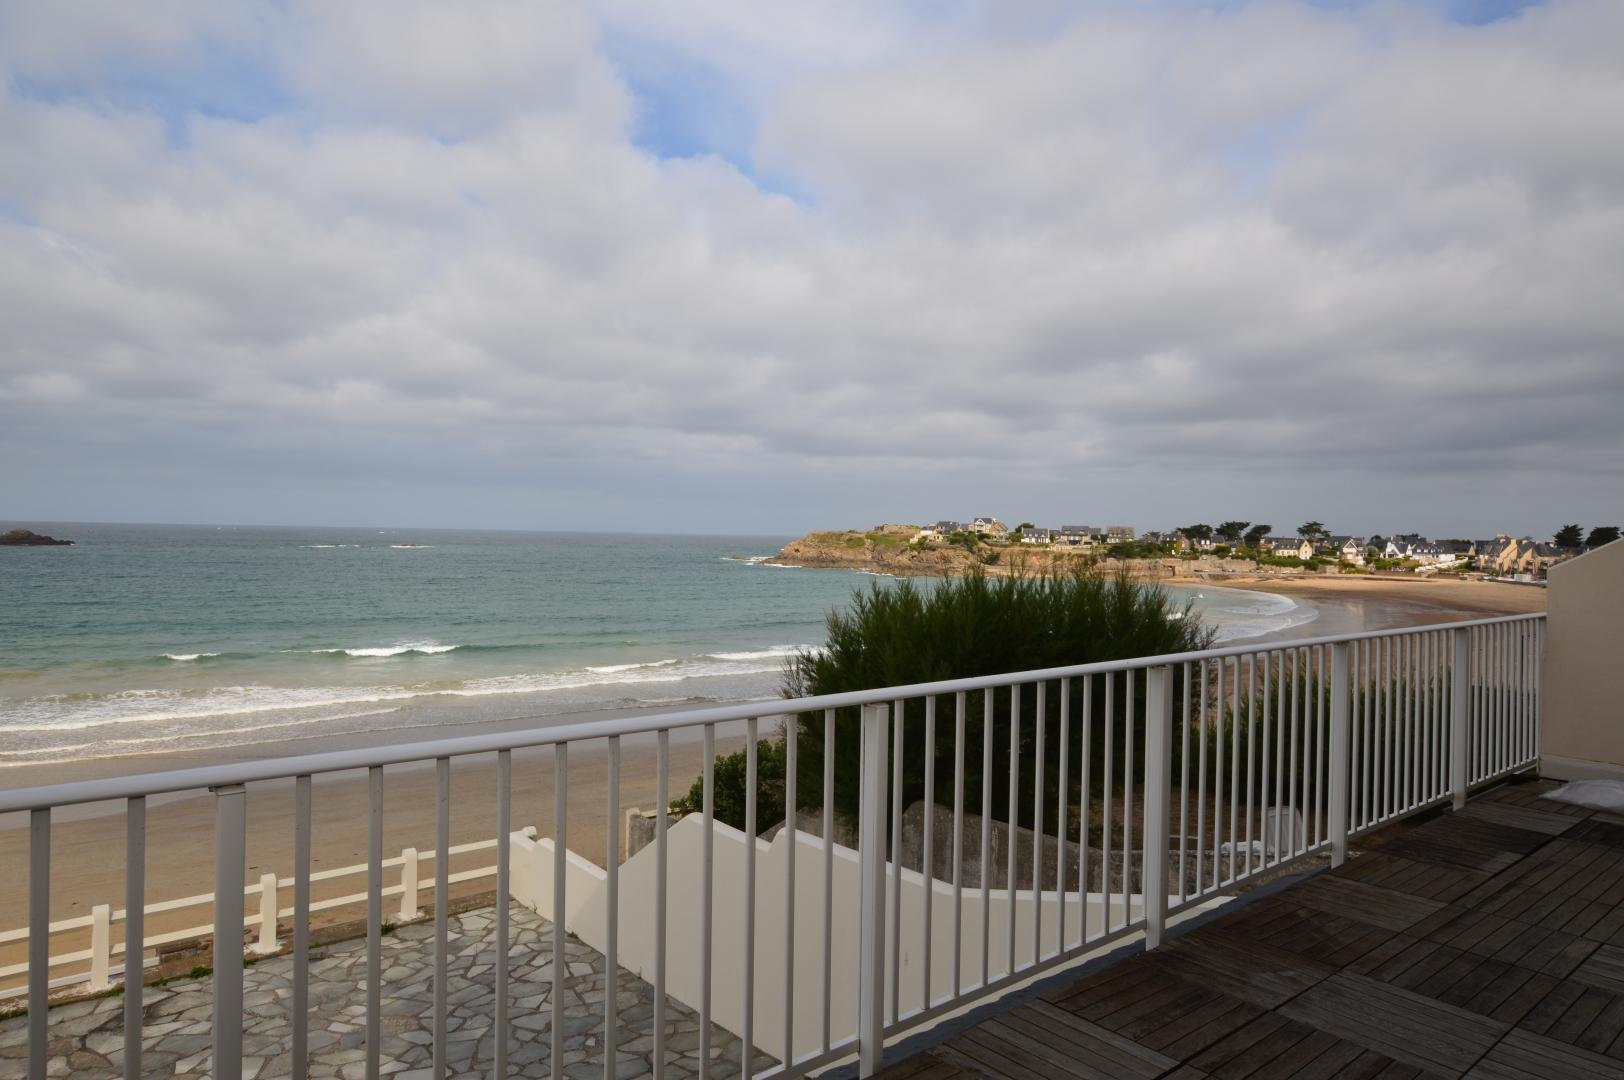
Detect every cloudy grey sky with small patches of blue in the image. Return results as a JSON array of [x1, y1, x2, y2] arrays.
[[0, 0, 1624, 536]]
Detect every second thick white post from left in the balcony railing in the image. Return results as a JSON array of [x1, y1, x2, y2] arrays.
[[857, 705, 888, 1077]]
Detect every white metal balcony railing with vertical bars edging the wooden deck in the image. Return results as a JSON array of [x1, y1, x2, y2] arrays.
[[0, 616, 1544, 1080]]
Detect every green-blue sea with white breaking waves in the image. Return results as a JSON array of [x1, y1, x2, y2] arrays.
[[0, 523, 1315, 775]]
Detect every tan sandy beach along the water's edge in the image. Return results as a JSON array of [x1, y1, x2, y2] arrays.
[[0, 575, 1544, 987]]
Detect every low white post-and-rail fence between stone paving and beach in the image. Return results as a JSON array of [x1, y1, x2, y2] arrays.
[[0, 825, 536, 999]]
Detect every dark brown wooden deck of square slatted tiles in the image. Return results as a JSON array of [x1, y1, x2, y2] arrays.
[[882, 783, 1624, 1080]]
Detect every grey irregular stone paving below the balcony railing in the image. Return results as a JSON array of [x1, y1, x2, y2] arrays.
[[0, 906, 771, 1080]]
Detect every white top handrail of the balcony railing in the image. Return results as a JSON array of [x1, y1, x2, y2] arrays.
[[0, 612, 1544, 814]]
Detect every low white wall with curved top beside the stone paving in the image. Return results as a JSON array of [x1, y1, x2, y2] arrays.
[[512, 815, 1162, 1057]]
